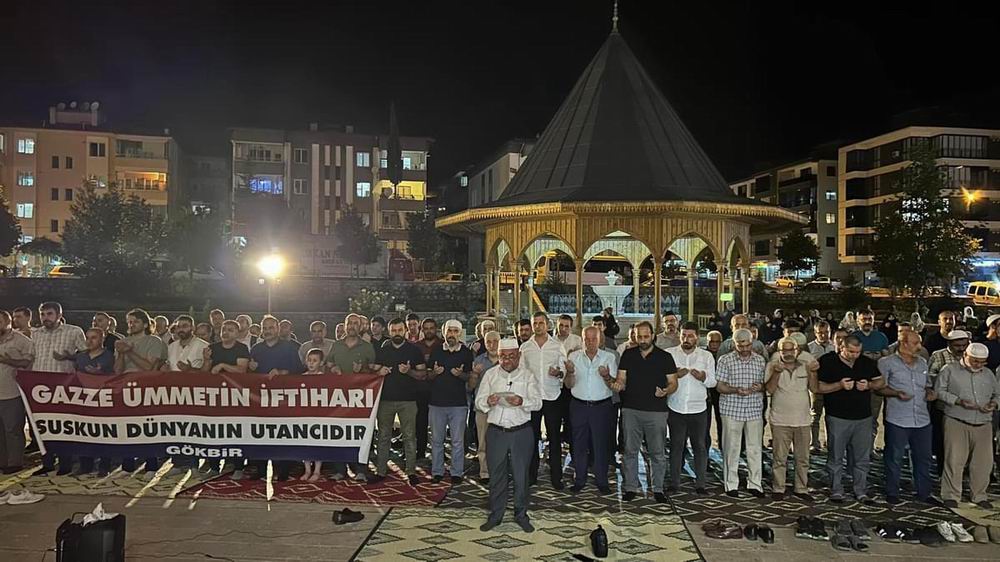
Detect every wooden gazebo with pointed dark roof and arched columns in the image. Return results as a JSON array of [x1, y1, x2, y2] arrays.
[[436, 31, 806, 325]]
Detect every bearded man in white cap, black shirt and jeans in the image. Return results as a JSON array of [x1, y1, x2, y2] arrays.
[[427, 320, 475, 484]]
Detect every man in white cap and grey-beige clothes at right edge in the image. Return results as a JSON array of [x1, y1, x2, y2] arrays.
[[934, 343, 1000, 509]]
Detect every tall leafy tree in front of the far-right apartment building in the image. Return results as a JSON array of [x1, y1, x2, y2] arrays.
[[872, 142, 979, 298]]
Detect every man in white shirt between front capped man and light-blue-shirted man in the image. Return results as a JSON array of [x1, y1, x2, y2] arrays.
[[521, 312, 572, 490]]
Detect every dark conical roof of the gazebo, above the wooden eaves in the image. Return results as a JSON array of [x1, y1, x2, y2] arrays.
[[492, 33, 747, 207]]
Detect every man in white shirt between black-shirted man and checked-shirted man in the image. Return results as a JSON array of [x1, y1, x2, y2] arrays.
[[668, 322, 716, 495]]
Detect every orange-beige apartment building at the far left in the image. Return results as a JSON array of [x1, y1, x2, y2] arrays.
[[0, 102, 180, 262]]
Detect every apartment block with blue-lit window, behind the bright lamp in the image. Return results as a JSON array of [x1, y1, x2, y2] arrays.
[[228, 124, 432, 252]]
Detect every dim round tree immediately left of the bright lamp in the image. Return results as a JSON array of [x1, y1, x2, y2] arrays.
[[167, 209, 227, 278]]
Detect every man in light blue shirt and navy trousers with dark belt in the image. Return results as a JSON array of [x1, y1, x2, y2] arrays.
[[563, 326, 618, 495]]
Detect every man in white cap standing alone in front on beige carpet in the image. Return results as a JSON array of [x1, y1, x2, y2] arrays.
[[476, 338, 542, 533]]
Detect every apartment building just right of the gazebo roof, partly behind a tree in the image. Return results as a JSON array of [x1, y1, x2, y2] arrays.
[[730, 154, 843, 281]]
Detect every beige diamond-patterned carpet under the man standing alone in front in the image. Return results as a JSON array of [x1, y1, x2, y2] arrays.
[[355, 508, 701, 562]]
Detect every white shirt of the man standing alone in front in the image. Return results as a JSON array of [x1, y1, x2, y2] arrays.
[[476, 364, 542, 428]]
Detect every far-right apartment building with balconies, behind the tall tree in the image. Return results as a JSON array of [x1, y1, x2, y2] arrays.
[[837, 127, 1000, 279]]
